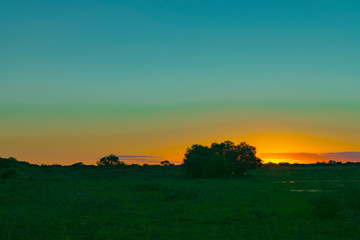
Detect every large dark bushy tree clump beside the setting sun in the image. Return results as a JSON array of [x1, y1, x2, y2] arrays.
[[183, 141, 261, 177]]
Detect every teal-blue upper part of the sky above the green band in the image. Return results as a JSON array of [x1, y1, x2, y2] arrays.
[[0, 0, 360, 103]]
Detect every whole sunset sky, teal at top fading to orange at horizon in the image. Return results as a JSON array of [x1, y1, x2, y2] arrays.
[[0, 0, 360, 165]]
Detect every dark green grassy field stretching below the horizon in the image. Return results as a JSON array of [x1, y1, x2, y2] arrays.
[[0, 167, 360, 240]]
